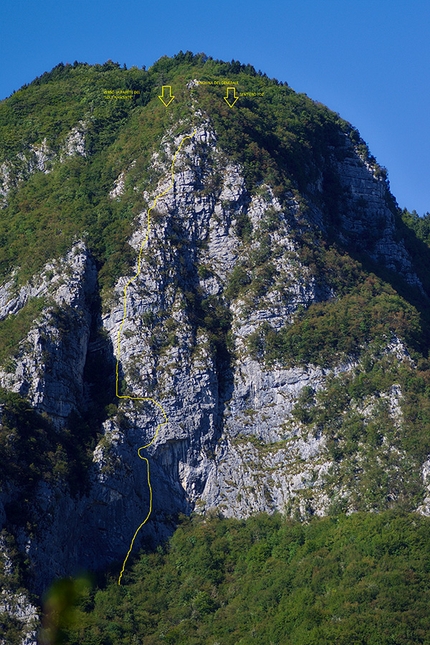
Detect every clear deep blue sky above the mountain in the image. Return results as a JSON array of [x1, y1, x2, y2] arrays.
[[0, 0, 430, 215]]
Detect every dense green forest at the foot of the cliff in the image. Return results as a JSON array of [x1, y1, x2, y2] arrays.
[[45, 512, 430, 645]]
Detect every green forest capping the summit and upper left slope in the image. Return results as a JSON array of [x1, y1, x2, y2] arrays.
[[0, 54, 358, 285]]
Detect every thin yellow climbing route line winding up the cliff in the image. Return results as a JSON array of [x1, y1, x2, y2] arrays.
[[115, 130, 197, 585]]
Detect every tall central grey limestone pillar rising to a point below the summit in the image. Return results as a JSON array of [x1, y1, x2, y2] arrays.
[[98, 126, 328, 522]]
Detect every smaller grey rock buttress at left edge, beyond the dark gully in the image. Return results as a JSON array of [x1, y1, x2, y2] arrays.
[[0, 243, 97, 425]]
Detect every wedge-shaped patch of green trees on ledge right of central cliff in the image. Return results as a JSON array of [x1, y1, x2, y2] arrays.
[[249, 275, 423, 366]]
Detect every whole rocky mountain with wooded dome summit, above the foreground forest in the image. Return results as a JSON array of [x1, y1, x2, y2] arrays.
[[0, 53, 430, 645]]
